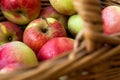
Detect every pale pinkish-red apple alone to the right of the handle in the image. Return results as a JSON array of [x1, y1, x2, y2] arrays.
[[102, 6, 120, 35]]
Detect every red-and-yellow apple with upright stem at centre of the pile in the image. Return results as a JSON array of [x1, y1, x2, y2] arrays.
[[23, 18, 67, 54]]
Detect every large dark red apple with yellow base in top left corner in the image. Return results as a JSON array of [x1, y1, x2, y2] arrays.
[[1, 0, 41, 25]]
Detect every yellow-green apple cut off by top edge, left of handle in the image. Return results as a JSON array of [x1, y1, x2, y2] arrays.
[[49, 0, 76, 16]]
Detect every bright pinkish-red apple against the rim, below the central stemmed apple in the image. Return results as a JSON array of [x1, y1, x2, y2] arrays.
[[38, 37, 74, 60]]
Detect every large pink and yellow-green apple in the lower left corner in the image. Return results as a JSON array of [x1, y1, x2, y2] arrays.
[[0, 41, 38, 73]]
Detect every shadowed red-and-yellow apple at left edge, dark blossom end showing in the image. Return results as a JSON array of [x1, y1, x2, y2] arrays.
[[0, 21, 23, 45]]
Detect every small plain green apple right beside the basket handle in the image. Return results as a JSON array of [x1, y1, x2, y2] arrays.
[[68, 14, 83, 36]]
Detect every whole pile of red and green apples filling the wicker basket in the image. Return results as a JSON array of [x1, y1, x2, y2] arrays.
[[0, 0, 120, 73]]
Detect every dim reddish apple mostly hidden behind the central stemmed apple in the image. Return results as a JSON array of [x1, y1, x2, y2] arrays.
[[39, 6, 67, 29]]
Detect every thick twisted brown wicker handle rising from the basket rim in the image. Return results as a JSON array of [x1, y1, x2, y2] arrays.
[[73, 0, 102, 52]]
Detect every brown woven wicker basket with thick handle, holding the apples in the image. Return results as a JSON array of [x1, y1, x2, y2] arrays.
[[0, 0, 120, 80]]
